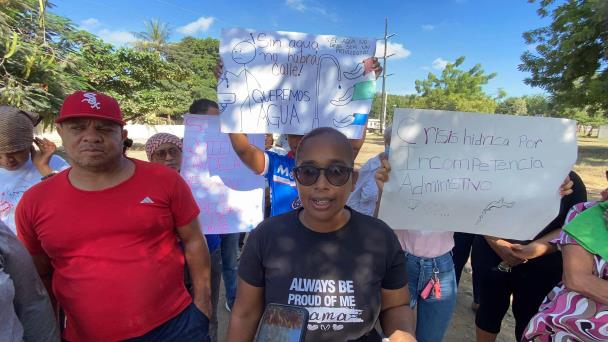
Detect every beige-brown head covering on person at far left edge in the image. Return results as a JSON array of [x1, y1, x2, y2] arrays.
[[0, 106, 39, 153]]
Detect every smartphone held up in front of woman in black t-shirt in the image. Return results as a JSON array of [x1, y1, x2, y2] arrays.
[[255, 303, 308, 342]]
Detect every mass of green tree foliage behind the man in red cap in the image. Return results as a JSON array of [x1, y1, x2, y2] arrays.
[[0, 0, 219, 123]]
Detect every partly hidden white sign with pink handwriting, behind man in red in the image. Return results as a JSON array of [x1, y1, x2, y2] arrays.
[[181, 114, 264, 234]]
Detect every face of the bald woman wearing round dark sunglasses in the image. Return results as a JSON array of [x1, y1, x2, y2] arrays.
[[296, 135, 353, 230]]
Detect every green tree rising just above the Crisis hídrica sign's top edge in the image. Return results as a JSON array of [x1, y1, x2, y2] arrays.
[[412, 57, 504, 113]]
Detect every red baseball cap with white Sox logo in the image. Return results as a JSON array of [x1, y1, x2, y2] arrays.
[[55, 90, 125, 126]]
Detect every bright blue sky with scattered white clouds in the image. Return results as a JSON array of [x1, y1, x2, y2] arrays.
[[52, 0, 548, 96]]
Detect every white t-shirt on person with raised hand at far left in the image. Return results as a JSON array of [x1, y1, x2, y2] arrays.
[[0, 155, 70, 235]]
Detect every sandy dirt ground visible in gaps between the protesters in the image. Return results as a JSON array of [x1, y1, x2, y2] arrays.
[[124, 134, 608, 342]]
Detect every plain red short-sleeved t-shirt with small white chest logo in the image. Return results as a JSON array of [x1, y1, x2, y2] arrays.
[[16, 160, 199, 341]]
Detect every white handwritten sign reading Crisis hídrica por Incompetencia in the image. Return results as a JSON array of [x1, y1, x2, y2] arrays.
[[379, 109, 577, 240]]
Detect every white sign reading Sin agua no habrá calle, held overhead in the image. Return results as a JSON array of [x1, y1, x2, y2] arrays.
[[217, 29, 376, 139]]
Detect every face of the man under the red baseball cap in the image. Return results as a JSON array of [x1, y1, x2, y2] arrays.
[[57, 118, 127, 171]]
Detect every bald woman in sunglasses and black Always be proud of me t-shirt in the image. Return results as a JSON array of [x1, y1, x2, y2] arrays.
[[228, 128, 414, 341]]
